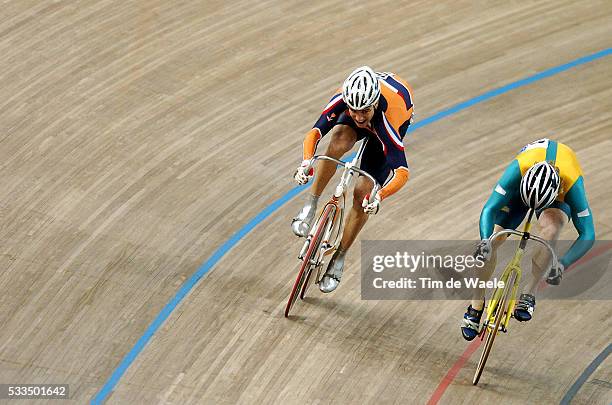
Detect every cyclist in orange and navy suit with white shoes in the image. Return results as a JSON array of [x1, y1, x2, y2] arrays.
[[292, 66, 413, 292]]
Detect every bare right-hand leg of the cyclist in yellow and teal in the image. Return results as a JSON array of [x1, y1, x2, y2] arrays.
[[523, 205, 569, 296]]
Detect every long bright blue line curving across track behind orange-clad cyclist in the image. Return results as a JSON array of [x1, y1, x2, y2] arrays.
[[91, 48, 612, 405]]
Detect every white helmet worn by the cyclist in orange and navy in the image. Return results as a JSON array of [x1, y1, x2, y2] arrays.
[[342, 66, 380, 110]]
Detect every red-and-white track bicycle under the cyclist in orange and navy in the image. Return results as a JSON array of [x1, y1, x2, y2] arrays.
[[285, 139, 380, 317]]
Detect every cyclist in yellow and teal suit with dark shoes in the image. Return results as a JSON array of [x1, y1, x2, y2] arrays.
[[461, 139, 595, 340]]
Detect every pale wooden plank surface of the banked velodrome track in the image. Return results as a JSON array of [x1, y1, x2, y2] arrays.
[[0, 0, 612, 404]]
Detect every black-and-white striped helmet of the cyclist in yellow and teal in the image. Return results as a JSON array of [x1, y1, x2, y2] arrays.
[[521, 162, 560, 210]]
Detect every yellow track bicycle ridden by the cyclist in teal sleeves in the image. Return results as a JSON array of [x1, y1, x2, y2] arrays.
[[472, 210, 558, 385]]
